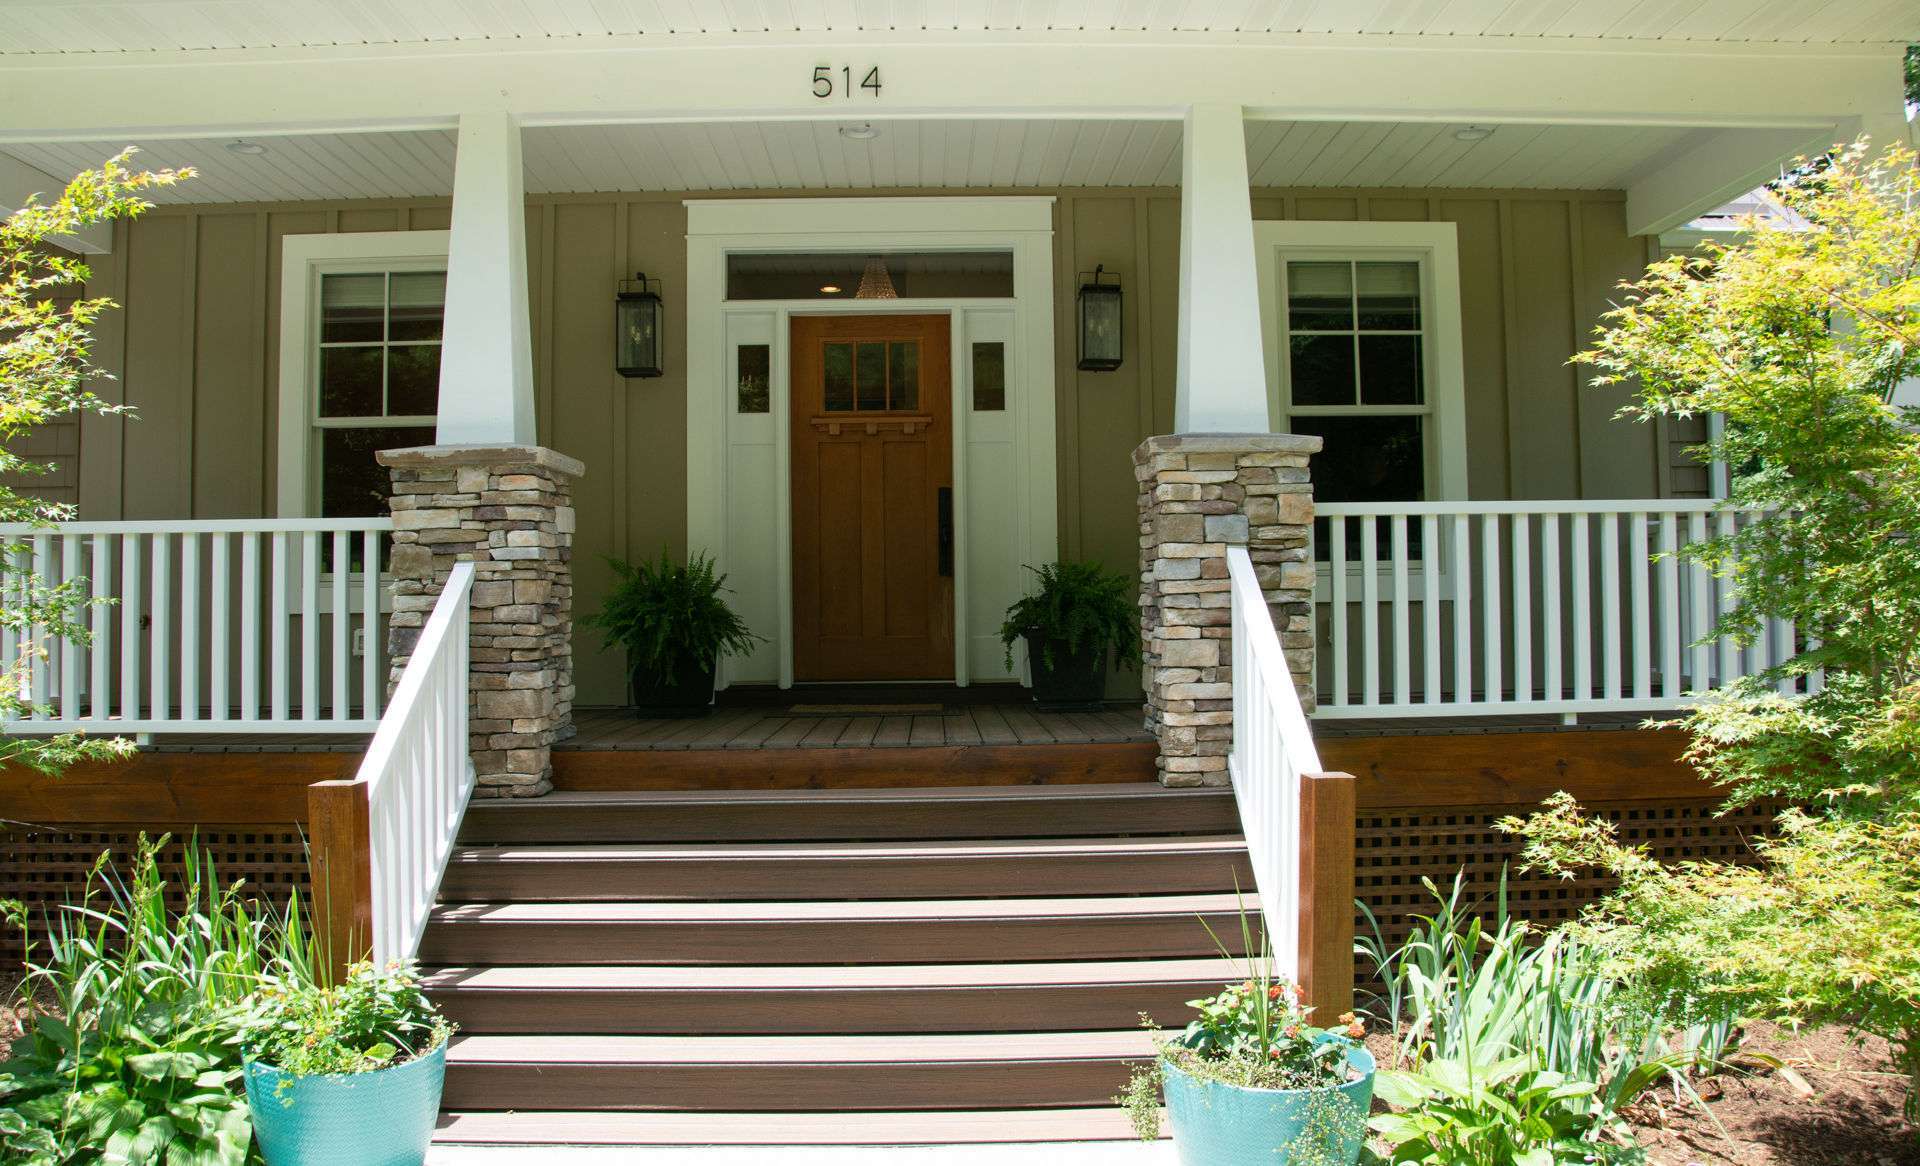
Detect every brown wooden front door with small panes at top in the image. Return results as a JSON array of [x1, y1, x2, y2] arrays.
[[791, 315, 954, 680]]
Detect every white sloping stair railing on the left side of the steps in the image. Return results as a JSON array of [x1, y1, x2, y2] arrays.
[[353, 563, 474, 964]]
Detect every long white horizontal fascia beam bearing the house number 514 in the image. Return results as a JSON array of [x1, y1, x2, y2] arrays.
[[0, 31, 1901, 142]]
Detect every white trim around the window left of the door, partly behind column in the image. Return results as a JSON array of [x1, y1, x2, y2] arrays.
[[275, 231, 449, 519]]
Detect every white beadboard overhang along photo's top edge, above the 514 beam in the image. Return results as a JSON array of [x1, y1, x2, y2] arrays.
[[0, 0, 1920, 54]]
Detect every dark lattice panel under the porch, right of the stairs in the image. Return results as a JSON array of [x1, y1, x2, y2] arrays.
[[1354, 799, 1780, 980]]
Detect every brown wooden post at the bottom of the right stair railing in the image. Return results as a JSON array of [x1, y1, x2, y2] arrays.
[[1300, 774, 1356, 1026]]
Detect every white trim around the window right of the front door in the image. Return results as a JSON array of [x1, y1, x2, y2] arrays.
[[1254, 219, 1467, 501]]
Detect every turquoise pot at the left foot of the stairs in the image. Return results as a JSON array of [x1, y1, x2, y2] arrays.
[[246, 1043, 447, 1166]]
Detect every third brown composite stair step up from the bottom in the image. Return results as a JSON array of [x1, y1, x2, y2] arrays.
[[424, 957, 1242, 1033]]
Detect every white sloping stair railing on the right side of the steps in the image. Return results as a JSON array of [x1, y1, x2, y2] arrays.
[[1227, 547, 1321, 984]]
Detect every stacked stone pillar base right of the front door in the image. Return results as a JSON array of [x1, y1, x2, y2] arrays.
[[1133, 434, 1321, 786]]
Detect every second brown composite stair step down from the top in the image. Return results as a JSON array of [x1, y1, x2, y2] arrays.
[[440, 834, 1252, 903]]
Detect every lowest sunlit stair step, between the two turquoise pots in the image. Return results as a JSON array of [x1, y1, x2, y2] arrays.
[[434, 1105, 1133, 1147]]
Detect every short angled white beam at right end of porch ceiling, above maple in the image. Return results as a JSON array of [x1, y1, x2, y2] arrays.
[[1626, 125, 1847, 234]]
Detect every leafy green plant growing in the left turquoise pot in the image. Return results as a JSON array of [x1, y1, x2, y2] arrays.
[[238, 964, 453, 1078]]
